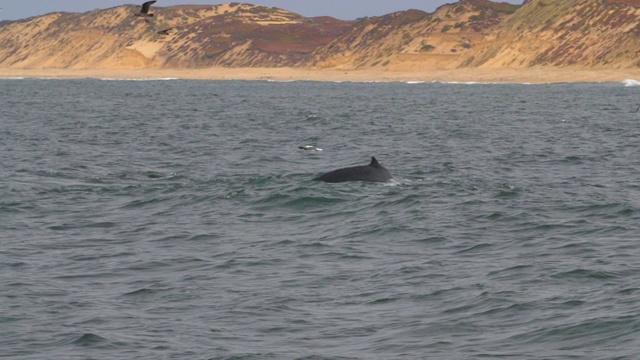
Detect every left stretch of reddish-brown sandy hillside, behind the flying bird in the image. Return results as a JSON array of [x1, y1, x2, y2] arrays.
[[0, 3, 351, 69]]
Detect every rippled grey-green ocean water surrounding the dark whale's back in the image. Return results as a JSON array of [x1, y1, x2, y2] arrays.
[[0, 79, 640, 360]]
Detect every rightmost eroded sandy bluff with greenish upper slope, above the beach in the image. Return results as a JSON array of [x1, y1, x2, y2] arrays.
[[468, 0, 640, 68]]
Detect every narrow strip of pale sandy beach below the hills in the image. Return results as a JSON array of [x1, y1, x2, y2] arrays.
[[0, 68, 640, 83]]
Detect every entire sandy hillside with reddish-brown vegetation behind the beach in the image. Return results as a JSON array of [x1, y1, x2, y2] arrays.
[[0, 0, 640, 70]]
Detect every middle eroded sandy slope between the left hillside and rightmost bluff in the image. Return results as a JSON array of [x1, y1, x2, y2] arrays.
[[309, 0, 518, 69]]
